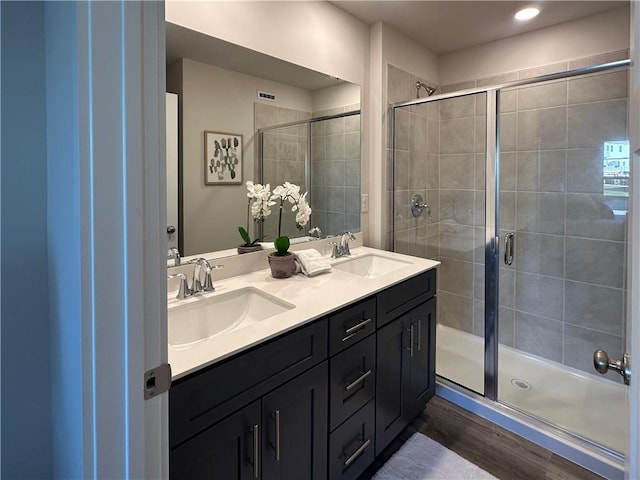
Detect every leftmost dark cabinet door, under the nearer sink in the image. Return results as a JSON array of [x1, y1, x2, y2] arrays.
[[169, 400, 260, 480]]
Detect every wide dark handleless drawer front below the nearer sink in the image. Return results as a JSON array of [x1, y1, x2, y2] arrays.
[[169, 319, 328, 447]]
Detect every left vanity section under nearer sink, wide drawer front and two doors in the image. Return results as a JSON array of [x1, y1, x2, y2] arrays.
[[169, 319, 329, 480]]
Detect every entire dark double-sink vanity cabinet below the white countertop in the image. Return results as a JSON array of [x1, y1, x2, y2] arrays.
[[169, 270, 436, 480]]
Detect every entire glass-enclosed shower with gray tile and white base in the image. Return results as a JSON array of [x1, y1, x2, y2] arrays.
[[390, 60, 630, 476]]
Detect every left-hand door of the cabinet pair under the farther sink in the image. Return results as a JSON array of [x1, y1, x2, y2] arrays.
[[376, 315, 410, 455]]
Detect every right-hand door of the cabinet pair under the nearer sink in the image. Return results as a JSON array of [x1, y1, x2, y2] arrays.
[[262, 362, 328, 480]]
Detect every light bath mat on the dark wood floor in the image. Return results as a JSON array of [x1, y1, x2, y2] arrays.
[[373, 433, 496, 480]]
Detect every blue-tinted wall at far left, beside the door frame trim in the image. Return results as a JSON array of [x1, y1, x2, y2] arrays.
[[0, 2, 52, 478]]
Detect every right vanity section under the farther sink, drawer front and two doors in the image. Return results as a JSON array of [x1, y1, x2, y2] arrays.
[[375, 271, 436, 455]]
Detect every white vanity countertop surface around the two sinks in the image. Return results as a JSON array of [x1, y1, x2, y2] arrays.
[[168, 247, 440, 380]]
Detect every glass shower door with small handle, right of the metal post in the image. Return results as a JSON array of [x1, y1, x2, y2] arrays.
[[498, 70, 630, 453]]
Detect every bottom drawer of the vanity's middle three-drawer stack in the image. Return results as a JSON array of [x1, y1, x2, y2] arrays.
[[329, 400, 375, 480]]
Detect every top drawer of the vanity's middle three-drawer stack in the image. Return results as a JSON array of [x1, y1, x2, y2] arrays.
[[329, 297, 376, 355]]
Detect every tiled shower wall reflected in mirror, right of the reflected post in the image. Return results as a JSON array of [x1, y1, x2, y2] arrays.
[[311, 104, 360, 235]]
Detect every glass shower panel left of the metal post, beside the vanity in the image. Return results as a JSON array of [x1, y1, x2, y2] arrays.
[[391, 93, 487, 394]]
